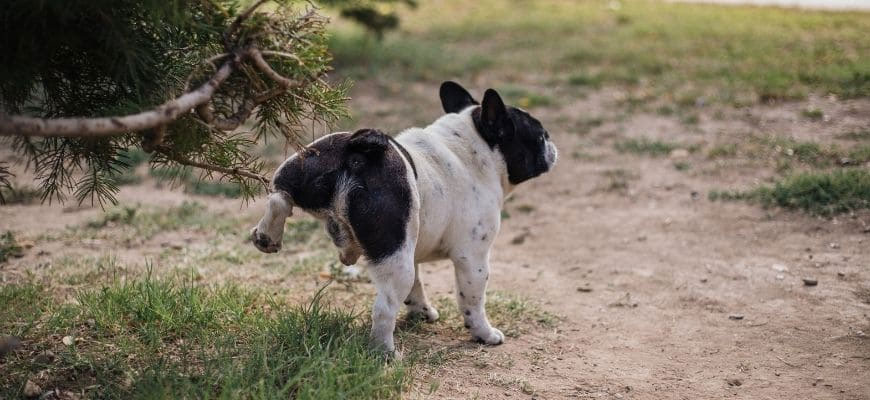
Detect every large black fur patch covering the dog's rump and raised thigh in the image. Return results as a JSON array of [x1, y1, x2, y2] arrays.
[[273, 129, 411, 263]]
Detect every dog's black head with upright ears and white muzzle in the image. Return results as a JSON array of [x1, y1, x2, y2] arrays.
[[440, 81, 558, 185]]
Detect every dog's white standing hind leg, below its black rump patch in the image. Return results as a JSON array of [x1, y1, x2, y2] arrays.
[[369, 252, 414, 358]]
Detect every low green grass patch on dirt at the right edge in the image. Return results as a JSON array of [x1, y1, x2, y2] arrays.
[[709, 168, 870, 216]]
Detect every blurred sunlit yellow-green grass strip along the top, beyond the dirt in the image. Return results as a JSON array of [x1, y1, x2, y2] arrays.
[[331, 0, 870, 104]]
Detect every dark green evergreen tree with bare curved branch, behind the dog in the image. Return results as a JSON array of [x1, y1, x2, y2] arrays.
[[0, 0, 348, 204]]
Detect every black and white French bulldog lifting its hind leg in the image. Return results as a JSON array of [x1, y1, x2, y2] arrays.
[[251, 82, 556, 353]]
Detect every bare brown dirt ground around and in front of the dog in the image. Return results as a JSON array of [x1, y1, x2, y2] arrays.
[[0, 86, 870, 399]]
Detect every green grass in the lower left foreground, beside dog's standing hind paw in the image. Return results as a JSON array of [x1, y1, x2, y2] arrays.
[[0, 278, 413, 399]]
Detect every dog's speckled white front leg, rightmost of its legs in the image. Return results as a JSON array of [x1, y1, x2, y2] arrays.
[[453, 250, 504, 345]]
